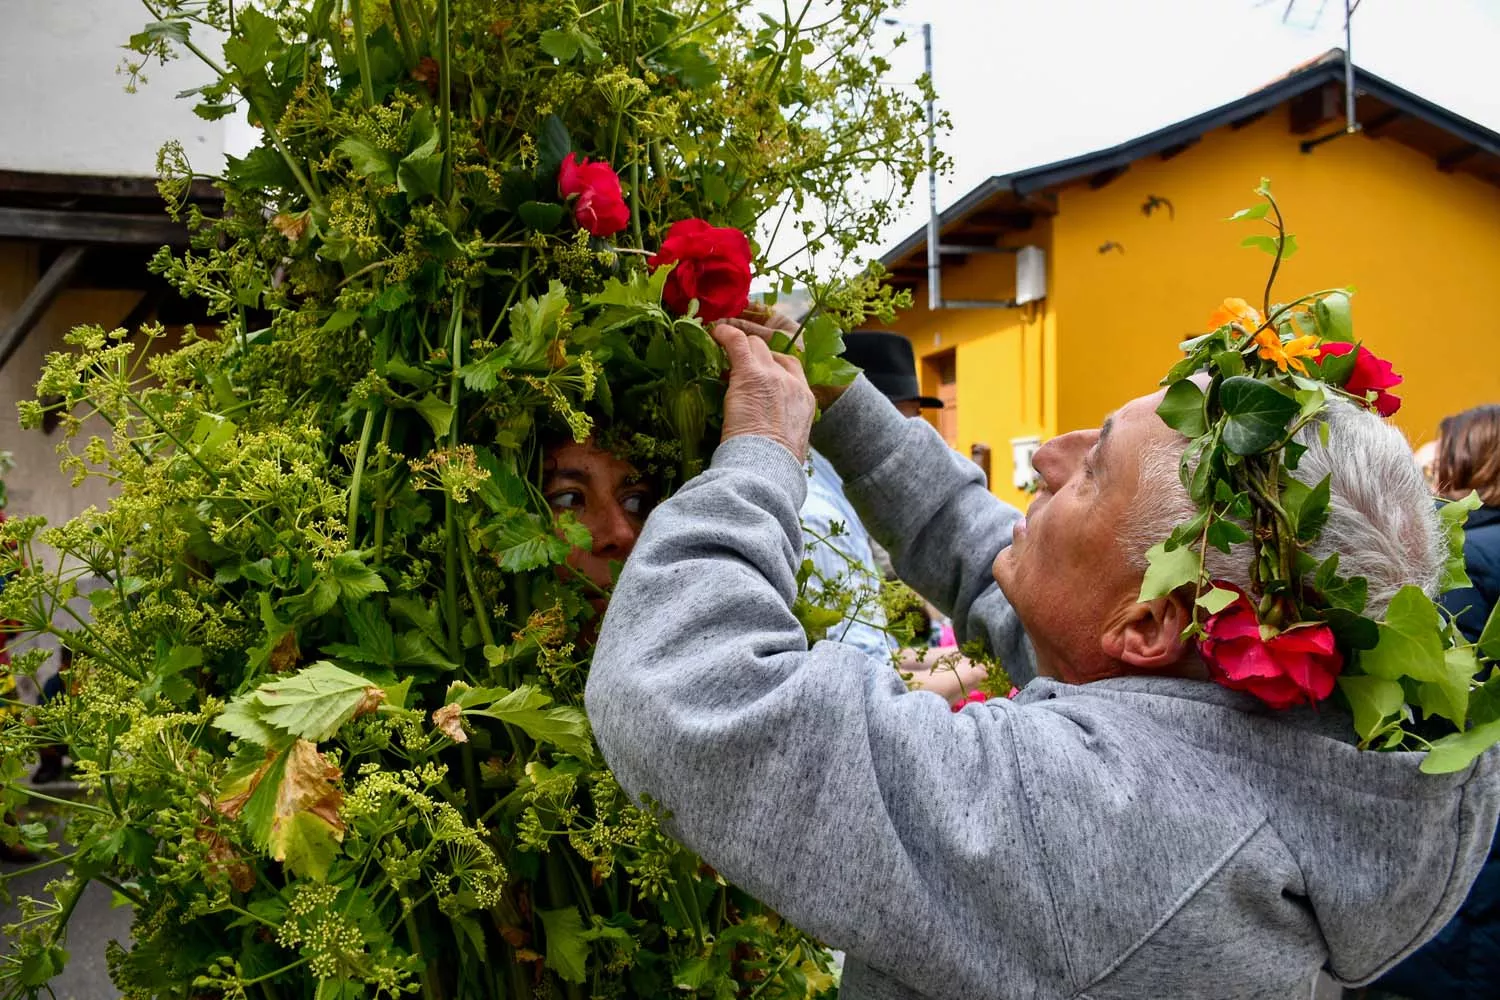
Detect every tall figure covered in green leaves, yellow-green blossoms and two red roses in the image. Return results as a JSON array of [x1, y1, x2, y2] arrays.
[[0, 0, 924, 1000]]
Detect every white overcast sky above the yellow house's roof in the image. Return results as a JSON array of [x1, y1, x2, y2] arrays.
[[881, 0, 1500, 257]]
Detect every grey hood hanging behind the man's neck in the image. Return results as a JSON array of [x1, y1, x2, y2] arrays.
[[1020, 678, 1500, 985]]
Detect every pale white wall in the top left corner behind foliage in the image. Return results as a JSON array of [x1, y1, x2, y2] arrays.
[[0, 0, 232, 177]]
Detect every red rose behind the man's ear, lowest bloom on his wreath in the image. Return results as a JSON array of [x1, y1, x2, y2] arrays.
[[1199, 583, 1344, 708]]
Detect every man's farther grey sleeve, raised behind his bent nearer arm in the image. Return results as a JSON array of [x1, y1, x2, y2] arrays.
[[813, 378, 1035, 684]]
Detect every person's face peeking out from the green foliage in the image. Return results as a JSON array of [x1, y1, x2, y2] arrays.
[[542, 439, 657, 610]]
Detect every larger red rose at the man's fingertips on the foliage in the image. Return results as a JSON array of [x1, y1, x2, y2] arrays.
[[648, 219, 750, 322]]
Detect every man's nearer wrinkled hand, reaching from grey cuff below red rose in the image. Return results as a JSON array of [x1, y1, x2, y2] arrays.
[[714, 321, 818, 462]]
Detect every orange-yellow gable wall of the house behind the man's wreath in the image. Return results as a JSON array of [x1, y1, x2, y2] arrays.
[[1050, 106, 1500, 444]]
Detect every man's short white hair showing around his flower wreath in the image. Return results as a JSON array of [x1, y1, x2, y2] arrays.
[[1121, 400, 1448, 618]]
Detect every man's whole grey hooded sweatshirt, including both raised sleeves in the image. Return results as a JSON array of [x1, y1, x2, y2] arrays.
[[587, 379, 1500, 1000]]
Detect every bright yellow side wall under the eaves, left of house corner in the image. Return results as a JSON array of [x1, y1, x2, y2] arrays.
[[891, 220, 1058, 508]]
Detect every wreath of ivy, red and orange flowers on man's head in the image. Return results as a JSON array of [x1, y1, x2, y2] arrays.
[[1140, 180, 1500, 774]]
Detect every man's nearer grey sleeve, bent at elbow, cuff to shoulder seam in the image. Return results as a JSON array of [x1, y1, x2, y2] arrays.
[[587, 438, 1067, 997]]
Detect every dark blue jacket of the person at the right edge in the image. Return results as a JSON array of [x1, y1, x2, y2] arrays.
[[1377, 507, 1500, 1000]]
